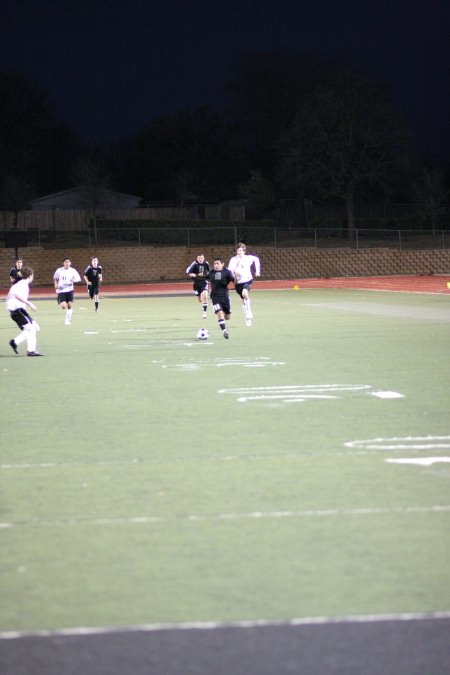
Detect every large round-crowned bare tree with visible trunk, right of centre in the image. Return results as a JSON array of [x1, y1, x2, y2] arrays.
[[278, 70, 410, 236]]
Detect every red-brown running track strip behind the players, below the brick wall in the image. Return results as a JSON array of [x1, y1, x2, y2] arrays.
[[20, 274, 450, 297]]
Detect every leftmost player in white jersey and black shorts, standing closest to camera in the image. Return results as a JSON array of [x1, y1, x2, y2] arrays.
[[6, 267, 44, 356]]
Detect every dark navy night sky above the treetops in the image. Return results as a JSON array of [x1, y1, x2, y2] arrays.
[[0, 0, 450, 160]]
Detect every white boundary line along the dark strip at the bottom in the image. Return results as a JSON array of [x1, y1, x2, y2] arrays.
[[0, 611, 450, 640]]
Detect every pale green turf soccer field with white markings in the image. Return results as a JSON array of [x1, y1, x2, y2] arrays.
[[0, 290, 450, 632]]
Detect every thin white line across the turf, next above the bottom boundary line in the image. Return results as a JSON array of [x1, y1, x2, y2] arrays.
[[0, 504, 450, 529]]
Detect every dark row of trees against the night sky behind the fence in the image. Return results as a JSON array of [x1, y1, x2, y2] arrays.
[[0, 52, 448, 228]]
